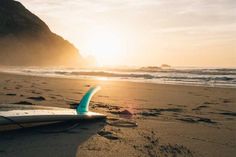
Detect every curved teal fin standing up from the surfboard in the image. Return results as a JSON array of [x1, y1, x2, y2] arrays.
[[76, 86, 101, 114]]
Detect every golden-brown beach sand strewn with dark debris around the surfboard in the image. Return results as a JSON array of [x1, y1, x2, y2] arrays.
[[0, 73, 236, 157]]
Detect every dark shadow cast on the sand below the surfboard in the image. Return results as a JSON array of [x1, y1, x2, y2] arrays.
[[0, 120, 105, 157]]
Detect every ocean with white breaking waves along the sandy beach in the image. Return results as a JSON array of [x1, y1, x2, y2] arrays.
[[0, 67, 236, 88]]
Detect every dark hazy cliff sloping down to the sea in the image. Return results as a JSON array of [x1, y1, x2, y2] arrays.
[[0, 0, 84, 67]]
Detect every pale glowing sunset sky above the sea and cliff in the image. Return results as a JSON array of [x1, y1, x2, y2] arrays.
[[19, 0, 236, 67]]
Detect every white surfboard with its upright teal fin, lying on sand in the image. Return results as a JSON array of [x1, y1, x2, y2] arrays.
[[0, 86, 106, 125]]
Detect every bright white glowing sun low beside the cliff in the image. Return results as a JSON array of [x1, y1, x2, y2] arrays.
[[87, 29, 125, 66]]
